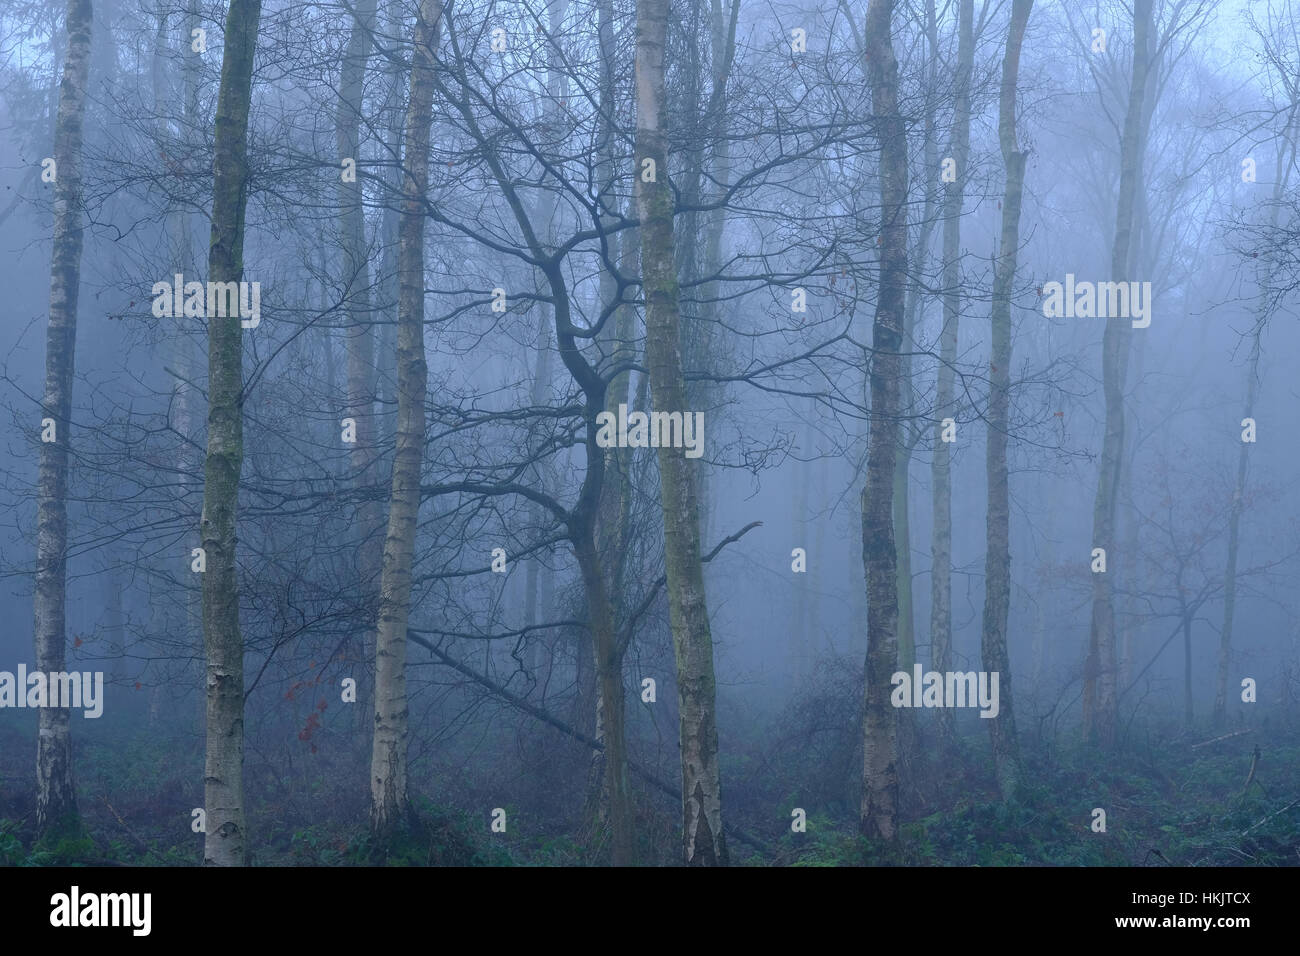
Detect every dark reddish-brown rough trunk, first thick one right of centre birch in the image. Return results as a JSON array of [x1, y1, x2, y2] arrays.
[[859, 0, 907, 840]]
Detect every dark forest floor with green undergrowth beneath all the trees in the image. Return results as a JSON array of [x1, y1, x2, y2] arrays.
[[0, 713, 1300, 866]]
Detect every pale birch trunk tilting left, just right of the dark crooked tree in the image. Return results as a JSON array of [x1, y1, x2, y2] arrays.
[[636, 0, 727, 866]]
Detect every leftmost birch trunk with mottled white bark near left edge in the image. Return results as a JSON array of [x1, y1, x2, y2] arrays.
[[33, 0, 92, 836]]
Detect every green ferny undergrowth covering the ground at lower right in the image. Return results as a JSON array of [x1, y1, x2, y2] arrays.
[[781, 737, 1300, 866]]
